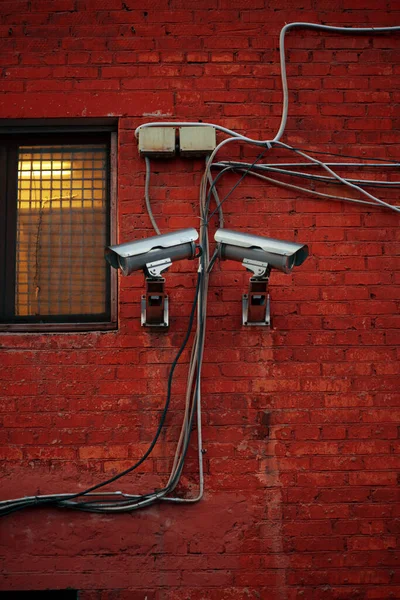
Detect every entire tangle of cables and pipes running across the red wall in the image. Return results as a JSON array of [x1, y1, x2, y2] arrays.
[[0, 22, 400, 516]]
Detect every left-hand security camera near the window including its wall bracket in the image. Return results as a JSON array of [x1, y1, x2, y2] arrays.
[[105, 228, 199, 329]]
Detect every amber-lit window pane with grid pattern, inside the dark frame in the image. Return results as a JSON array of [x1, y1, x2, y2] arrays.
[[15, 144, 107, 316]]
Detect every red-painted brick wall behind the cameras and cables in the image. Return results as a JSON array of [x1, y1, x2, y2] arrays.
[[0, 0, 400, 600]]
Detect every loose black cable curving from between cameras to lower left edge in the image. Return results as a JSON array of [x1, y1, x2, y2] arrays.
[[0, 272, 202, 516]]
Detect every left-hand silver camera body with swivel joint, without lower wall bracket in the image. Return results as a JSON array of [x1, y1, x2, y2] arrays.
[[105, 228, 199, 277]]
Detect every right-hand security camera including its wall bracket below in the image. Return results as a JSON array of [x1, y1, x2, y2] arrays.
[[215, 229, 308, 326]]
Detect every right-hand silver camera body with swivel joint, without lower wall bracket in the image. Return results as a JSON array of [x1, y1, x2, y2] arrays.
[[215, 229, 308, 276]]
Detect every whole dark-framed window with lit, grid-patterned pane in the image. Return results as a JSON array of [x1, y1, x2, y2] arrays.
[[0, 122, 116, 331]]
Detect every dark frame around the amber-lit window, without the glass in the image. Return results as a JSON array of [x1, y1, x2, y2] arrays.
[[0, 120, 118, 333]]
